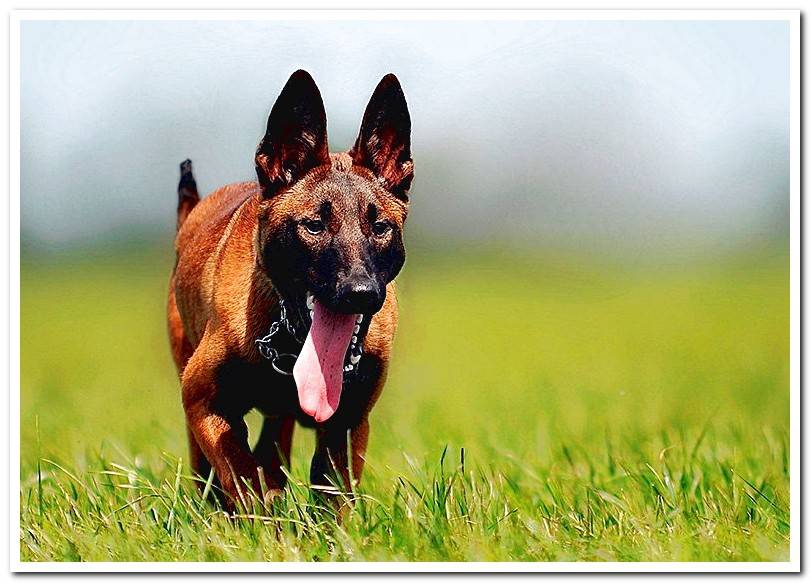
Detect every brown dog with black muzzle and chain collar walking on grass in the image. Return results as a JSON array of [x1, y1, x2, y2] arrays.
[[168, 71, 413, 507]]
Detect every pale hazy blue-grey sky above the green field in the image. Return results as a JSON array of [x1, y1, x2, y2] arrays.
[[21, 21, 789, 256]]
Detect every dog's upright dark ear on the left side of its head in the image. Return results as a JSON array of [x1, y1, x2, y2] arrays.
[[256, 70, 329, 198]]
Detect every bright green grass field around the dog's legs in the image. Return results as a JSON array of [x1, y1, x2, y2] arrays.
[[20, 245, 790, 561]]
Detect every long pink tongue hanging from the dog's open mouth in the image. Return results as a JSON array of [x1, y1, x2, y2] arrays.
[[293, 301, 358, 423]]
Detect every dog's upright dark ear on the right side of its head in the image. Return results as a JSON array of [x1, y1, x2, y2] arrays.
[[350, 73, 414, 200]]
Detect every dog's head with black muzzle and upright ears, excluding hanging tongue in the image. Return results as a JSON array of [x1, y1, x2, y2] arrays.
[[256, 71, 414, 422]]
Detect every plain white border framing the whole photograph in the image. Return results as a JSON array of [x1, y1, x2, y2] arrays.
[[9, 9, 801, 573]]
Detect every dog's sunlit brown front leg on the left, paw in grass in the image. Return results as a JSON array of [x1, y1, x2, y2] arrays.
[[183, 338, 261, 509]]
